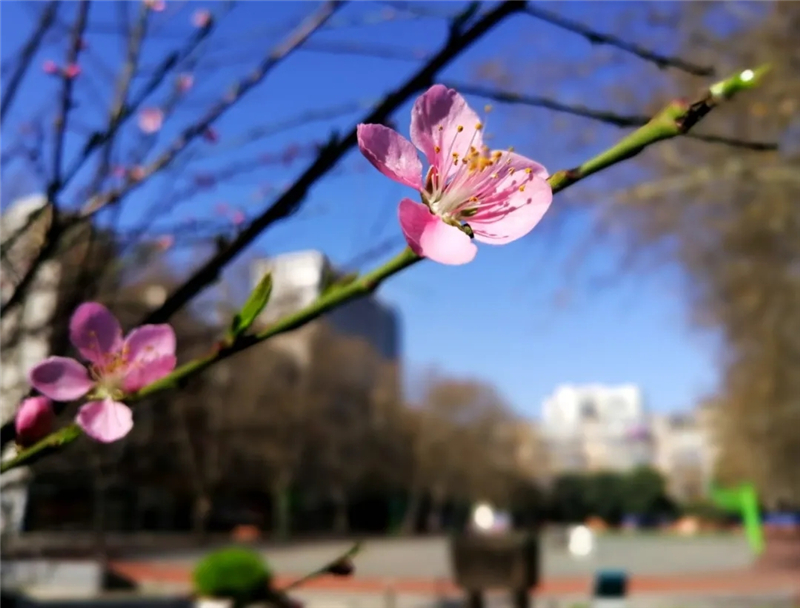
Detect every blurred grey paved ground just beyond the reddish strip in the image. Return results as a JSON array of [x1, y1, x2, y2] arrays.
[[145, 535, 753, 579]]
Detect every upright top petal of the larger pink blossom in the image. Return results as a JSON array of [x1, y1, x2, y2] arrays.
[[411, 84, 483, 178]]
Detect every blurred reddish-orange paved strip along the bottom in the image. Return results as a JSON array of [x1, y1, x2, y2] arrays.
[[112, 561, 800, 605]]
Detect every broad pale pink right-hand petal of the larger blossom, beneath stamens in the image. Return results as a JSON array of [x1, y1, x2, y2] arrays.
[[467, 177, 553, 245]]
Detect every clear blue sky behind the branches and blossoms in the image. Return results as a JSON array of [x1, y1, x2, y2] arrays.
[[2, 1, 716, 416]]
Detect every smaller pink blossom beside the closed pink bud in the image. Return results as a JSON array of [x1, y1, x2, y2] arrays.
[[28, 302, 176, 443]]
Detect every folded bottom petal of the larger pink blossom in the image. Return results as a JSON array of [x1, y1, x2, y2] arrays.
[[398, 198, 478, 265]]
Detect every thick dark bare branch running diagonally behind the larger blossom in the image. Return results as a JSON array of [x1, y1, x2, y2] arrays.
[[143, 1, 524, 323]]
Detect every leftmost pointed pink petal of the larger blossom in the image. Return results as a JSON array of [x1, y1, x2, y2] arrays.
[[357, 124, 422, 190]]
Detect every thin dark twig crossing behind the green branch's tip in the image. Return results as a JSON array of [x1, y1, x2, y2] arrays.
[[454, 83, 778, 152]]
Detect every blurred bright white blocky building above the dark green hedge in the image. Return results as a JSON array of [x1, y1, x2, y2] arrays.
[[542, 384, 653, 474]]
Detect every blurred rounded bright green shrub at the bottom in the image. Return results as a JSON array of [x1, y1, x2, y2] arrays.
[[192, 547, 272, 606]]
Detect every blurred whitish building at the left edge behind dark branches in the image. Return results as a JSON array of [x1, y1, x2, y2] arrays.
[[0, 195, 61, 534]]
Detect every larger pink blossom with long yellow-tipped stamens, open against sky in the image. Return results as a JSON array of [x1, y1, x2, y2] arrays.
[[358, 84, 553, 264]]
